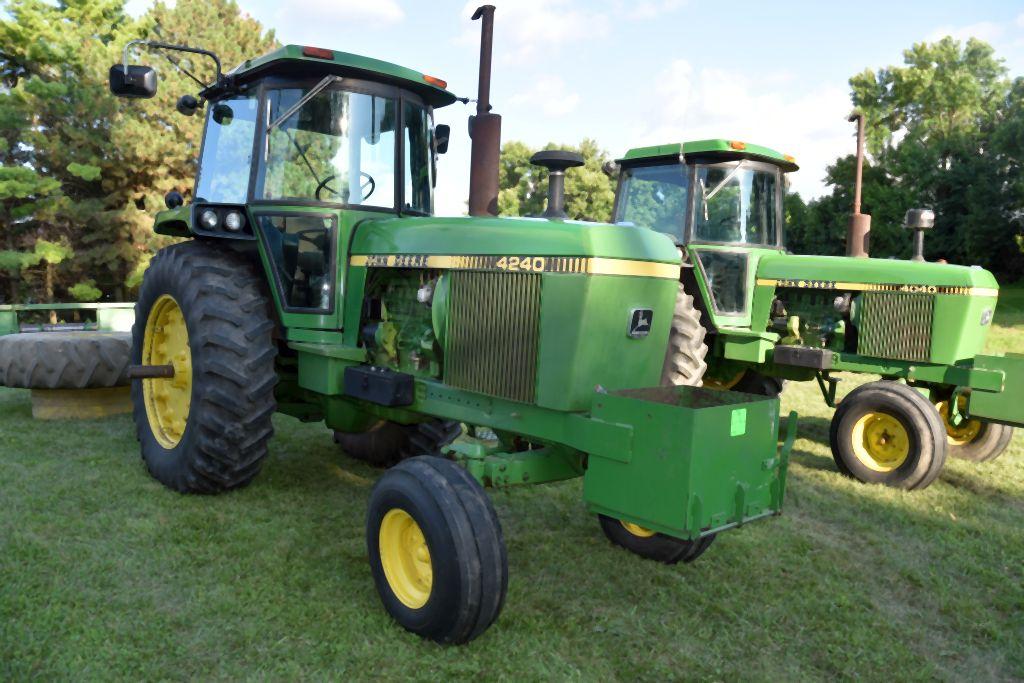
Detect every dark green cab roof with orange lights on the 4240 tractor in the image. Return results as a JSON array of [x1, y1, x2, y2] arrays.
[[228, 45, 456, 106]]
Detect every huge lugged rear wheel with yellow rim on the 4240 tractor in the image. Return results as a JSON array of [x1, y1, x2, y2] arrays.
[[131, 242, 278, 494]]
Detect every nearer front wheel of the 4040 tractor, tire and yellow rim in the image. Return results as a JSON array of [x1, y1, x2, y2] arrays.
[[829, 381, 946, 489]]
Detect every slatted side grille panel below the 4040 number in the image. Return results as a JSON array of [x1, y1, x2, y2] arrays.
[[857, 292, 935, 361]]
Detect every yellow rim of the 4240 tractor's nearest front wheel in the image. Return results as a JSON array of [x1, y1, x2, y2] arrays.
[[379, 508, 434, 609]]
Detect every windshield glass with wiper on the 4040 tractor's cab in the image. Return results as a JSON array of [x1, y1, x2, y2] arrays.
[[692, 160, 780, 246]]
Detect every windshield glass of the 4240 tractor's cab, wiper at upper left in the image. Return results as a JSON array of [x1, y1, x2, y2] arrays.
[[255, 86, 433, 214]]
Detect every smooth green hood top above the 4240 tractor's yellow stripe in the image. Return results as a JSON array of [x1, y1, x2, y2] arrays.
[[350, 217, 680, 265]]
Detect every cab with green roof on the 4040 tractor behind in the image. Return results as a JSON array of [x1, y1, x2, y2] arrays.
[[614, 139, 798, 327]]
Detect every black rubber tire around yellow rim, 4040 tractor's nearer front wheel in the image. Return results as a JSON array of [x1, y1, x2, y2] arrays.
[[828, 380, 948, 490]]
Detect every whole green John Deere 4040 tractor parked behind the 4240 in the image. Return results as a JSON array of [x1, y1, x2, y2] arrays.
[[614, 139, 1024, 488]]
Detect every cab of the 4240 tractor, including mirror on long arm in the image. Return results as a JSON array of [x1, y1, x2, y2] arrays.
[[111, 43, 456, 329]]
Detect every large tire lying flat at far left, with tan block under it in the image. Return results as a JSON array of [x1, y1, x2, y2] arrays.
[[0, 332, 131, 420]]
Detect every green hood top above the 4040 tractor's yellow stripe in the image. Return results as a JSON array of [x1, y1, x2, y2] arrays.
[[757, 254, 999, 291]]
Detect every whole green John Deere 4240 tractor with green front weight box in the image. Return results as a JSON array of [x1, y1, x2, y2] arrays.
[[111, 6, 796, 643]]
